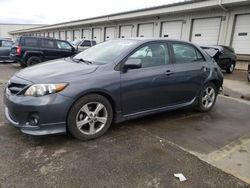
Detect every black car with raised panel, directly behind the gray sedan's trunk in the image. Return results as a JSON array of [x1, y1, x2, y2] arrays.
[[201, 45, 237, 73]]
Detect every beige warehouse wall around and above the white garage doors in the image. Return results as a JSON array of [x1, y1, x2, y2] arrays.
[[8, 5, 250, 55]]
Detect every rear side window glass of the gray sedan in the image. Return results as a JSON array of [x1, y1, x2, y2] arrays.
[[172, 43, 203, 63]]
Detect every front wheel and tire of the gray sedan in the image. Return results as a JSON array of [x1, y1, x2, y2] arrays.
[[67, 94, 113, 140]]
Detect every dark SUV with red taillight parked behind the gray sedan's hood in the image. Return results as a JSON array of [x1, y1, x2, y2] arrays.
[[10, 36, 77, 67]]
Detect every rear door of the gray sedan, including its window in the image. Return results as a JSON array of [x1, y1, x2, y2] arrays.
[[170, 42, 210, 104]]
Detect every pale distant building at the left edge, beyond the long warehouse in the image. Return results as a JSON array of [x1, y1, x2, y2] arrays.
[[0, 24, 44, 39]]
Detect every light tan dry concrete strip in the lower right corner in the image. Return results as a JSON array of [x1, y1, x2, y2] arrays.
[[139, 128, 250, 184]]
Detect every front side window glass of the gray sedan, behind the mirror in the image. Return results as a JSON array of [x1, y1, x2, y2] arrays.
[[129, 43, 169, 68]]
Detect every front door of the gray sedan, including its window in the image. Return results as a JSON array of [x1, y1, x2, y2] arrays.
[[121, 42, 174, 115]]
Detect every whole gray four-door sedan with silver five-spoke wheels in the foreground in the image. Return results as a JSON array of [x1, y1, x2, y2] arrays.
[[4, 38, 223, 140]]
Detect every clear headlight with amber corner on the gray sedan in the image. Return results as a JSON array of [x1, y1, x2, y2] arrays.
[[24, 83, 68, 97]]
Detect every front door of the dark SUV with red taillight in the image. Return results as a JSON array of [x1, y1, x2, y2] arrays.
[[56, 40, 76, 58]]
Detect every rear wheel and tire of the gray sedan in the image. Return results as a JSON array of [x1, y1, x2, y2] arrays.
[[197, 83, 218, 112]]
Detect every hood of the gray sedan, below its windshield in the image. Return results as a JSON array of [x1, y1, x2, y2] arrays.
[[15, 59, 98, 83]]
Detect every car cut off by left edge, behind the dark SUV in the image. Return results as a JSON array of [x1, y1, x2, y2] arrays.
[[0, 38, 13, 62]]
